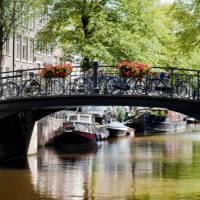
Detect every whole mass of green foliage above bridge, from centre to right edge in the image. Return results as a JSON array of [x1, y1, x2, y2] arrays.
[[35, 0, 200, 67]]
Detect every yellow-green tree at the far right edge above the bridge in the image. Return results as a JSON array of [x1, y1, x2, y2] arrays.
[[162, 0, 200, 69]]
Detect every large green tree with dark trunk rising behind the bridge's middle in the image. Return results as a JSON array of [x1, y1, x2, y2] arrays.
[[39, 0, 169, 67]]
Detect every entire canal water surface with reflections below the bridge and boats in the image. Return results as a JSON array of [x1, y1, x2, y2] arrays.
[[0, 126, 200, 200]]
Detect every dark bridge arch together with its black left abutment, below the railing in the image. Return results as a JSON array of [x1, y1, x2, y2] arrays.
[[0, 95, 200, 160]]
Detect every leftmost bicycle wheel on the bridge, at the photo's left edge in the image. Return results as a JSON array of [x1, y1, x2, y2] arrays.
[[2, 82, 19, 99]]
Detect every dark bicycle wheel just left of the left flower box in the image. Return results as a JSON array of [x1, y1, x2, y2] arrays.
[[23, 80, 41, 97]]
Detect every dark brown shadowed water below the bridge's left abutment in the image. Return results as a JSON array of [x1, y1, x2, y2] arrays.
[[0, 158, 54, 200]]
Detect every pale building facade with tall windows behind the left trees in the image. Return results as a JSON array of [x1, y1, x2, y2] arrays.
[[2, 16, 61, 72]]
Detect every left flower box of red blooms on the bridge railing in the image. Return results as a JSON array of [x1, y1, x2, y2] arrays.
[[40, 64, 73, 78]]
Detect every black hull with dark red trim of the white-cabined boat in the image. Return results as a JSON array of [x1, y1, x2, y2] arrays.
[[54, 131, 97, 148]]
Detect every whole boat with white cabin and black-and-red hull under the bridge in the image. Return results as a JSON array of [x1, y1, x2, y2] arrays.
[[54, 114, 97, 147]]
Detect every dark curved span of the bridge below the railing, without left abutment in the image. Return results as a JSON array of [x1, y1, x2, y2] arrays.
[[0, 95, 200, 119]]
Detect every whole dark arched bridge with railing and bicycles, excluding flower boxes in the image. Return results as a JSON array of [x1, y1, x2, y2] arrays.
[[0, 63, 200, 159]]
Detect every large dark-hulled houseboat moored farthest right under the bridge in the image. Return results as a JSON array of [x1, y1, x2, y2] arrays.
[[126, 108, 186, 136]]
